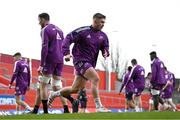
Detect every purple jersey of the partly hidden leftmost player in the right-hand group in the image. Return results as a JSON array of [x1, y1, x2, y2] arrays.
[[122, 72, 134, 93]]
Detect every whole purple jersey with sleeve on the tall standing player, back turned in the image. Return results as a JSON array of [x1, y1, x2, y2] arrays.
[[41, 24, 64, 66]]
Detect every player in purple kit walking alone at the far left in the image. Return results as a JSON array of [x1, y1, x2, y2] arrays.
[[9, 52, 32, 114]]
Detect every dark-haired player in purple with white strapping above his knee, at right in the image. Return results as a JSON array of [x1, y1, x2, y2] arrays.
[[150, 51, 166, 111]]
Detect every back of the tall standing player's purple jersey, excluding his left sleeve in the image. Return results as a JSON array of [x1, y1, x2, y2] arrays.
[[42, 24, 64, 63]]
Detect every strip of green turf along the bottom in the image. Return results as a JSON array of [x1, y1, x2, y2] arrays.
[[0, 112, 180, 120]]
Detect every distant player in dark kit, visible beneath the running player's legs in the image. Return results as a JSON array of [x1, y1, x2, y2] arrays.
[[78, 88, 87, 113]]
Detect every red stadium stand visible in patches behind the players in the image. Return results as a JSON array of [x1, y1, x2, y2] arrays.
[[0, 54, 179, 110]]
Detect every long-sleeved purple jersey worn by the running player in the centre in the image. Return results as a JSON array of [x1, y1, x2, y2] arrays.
[[62, 26, 109, 67]]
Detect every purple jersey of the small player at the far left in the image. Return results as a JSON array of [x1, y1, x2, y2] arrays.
[[10, 59, 31, 87]]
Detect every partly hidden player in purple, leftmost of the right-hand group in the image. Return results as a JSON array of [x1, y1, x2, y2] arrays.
[[119, 66, 135, 111]]
